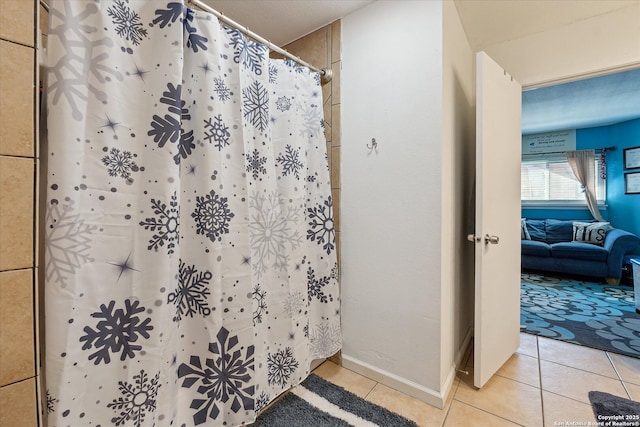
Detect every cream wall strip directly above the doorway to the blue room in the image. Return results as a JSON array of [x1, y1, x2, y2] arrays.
[[484, 3, 640, 86]]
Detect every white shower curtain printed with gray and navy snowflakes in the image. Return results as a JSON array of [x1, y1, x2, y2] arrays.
[[44, 0, 341, 427]]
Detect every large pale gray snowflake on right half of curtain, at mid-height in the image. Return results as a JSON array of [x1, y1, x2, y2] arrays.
[[249, 192, 302, 278]]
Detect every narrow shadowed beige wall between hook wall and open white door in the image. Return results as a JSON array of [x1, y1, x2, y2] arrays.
[[440, 1, 475, 393]]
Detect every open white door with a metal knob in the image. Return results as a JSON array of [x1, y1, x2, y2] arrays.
[[470, 52, 522, 388]]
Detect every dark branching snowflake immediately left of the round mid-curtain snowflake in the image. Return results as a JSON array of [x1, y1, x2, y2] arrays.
[[139, 191, 180, 255]]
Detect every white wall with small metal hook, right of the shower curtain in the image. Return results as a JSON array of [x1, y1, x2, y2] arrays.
[[341, 1, 450, 405]]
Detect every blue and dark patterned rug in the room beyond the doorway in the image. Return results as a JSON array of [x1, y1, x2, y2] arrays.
[[520, 273, 640, 358]]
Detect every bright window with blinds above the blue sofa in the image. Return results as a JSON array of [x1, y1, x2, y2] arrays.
[[520, 154, 606, 204]]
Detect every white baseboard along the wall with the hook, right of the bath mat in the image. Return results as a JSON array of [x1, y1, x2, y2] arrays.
[[342, 353, 444, 409]]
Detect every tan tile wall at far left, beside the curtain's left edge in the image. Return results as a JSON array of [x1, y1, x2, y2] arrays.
[[0, 0, 39, 427]]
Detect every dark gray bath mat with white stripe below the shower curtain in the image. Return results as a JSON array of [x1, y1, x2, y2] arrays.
[[251, 374, 418, 427]]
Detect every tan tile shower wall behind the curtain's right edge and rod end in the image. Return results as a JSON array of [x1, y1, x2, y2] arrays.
[[274, 20, 342, 364]]
